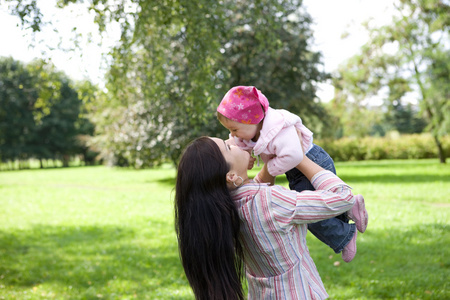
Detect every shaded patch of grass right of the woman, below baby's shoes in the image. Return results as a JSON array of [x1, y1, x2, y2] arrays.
[[308, 224, 450, 299]]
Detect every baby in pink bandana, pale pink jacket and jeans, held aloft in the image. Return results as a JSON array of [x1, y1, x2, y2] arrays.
[[217, 86, 368, 262]]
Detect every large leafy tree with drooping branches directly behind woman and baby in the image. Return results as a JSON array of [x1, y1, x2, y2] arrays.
[[1, 0, 329, 168]]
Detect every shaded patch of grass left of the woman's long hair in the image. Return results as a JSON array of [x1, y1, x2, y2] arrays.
[[0, 221, 189, 299]]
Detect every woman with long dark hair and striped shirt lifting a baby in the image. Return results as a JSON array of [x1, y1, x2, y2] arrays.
[[175, 137, 365, 300]]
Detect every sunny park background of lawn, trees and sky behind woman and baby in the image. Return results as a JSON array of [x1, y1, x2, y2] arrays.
[[0, 0, 450, 299]]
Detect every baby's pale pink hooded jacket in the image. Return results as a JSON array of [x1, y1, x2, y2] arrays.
[[234, 107, 313, 176]]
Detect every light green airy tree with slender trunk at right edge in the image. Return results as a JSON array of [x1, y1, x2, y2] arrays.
[[334, 0, 450, 163]]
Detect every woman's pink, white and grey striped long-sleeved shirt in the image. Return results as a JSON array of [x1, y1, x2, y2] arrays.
[[232, 171, 354, 300]]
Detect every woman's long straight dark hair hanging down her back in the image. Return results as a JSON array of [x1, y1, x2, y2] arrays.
[[175, 137, 244, 300]]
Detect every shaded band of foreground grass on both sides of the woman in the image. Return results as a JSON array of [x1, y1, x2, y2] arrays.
[[0, 221, 450, 299]]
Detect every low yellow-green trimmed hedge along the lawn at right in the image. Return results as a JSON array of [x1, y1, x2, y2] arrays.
[[315, 134, 450, 161]]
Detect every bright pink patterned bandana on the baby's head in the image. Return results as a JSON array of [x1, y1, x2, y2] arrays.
[[217, 86, 269, 124]]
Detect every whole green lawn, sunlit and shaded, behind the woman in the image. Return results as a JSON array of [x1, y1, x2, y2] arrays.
[[0, 160, 450, 299]]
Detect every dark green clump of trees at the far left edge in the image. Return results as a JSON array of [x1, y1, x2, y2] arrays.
[[0, 58, 93, 166]]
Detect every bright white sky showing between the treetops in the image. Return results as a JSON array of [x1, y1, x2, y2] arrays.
[[0, 0, 393, 102]]
